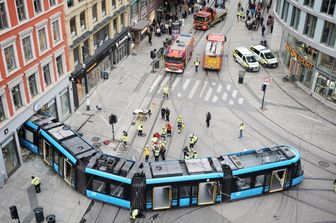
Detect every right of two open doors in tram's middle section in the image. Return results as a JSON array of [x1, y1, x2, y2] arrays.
[[198, 182, 217, 205]]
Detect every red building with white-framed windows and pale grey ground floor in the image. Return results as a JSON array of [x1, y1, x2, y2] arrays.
[[0, 0, 73, 180]]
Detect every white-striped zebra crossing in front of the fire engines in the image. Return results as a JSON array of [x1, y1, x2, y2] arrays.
[[148, 76, 244, 105]]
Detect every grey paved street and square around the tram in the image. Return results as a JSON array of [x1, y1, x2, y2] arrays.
[[0, 1, 336, 223]]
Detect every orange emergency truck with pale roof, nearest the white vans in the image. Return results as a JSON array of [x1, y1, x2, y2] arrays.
[[203, 33, 225, 71]]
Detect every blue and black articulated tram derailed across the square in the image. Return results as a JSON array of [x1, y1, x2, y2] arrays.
[[19, 114, 304, 211]]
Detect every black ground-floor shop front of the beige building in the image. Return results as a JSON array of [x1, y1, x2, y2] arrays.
[[70, 28, 131, 109]]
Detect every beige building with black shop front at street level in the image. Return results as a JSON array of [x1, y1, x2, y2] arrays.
[[65, 0, 131, 108]]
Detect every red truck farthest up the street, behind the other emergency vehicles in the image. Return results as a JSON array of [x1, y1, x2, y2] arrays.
[[194, 7, 227, 30]]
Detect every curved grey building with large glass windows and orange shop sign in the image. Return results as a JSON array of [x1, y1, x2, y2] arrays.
[[274, 0, 336, 107]]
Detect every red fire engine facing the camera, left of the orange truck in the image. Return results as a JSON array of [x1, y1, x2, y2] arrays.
[[165, 34, 194, 73]]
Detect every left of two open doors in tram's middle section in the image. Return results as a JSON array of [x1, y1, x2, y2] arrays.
[[153, 186, 172, 210]]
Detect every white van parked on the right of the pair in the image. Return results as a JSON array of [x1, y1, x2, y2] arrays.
[[250, 45, 278, 68]]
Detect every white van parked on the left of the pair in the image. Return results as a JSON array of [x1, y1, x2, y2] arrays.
[[233, 47, 260, 72]]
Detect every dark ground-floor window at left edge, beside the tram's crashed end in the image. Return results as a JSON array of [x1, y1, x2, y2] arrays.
[[1, 136, 20, 175]]
